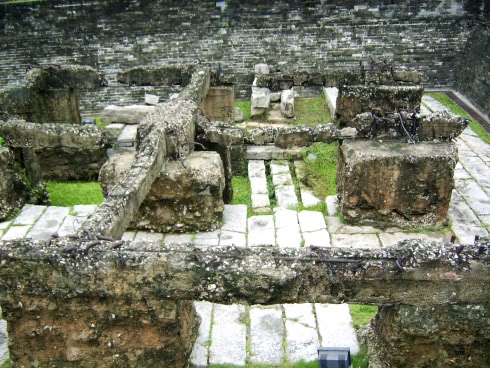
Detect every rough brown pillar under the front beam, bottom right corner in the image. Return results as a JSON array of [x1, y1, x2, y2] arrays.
[[369, 304, 490, 368]]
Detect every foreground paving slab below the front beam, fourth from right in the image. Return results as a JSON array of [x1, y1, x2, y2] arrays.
[[209, 304, 247, 366]]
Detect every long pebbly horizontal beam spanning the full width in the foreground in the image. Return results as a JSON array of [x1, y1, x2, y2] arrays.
[[0, 239, 490, 305]]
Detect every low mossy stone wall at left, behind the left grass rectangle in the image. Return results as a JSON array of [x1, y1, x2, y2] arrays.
[[0, 119, 112, 181]]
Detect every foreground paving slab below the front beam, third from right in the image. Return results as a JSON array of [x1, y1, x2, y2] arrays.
[[250, 305, 284, 365]]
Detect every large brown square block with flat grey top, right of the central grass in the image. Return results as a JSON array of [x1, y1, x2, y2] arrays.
[[337, 140, 457, 226]]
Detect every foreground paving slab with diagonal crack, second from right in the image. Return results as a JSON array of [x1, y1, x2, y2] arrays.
[[283, 304, 320, 362]]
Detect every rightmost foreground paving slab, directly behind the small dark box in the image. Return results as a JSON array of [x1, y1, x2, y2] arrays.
[[315, 304, 359, 355]]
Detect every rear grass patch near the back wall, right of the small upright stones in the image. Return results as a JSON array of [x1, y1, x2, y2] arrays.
[[294, 95, 332, 126]]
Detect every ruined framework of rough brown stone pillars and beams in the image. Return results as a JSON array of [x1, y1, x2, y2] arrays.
[[0, 61, 490, 368]]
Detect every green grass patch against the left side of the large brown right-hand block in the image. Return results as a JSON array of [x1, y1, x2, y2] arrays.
[[303, 143, 337, 199]]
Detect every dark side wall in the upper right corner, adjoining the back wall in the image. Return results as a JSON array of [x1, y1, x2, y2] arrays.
[[455, 21, 490, 115]]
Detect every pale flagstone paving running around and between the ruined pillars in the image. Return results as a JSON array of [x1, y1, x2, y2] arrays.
[[0, 129, 490, 367]]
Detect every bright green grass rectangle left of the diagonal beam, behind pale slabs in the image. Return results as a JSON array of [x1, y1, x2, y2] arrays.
[[46, 181, 104, 207]]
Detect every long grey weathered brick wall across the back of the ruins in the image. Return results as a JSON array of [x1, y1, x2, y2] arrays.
[[0, 0, 473, 110]]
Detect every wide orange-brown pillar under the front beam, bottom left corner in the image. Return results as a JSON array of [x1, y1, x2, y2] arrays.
[[2, 296, 199, 368]]
